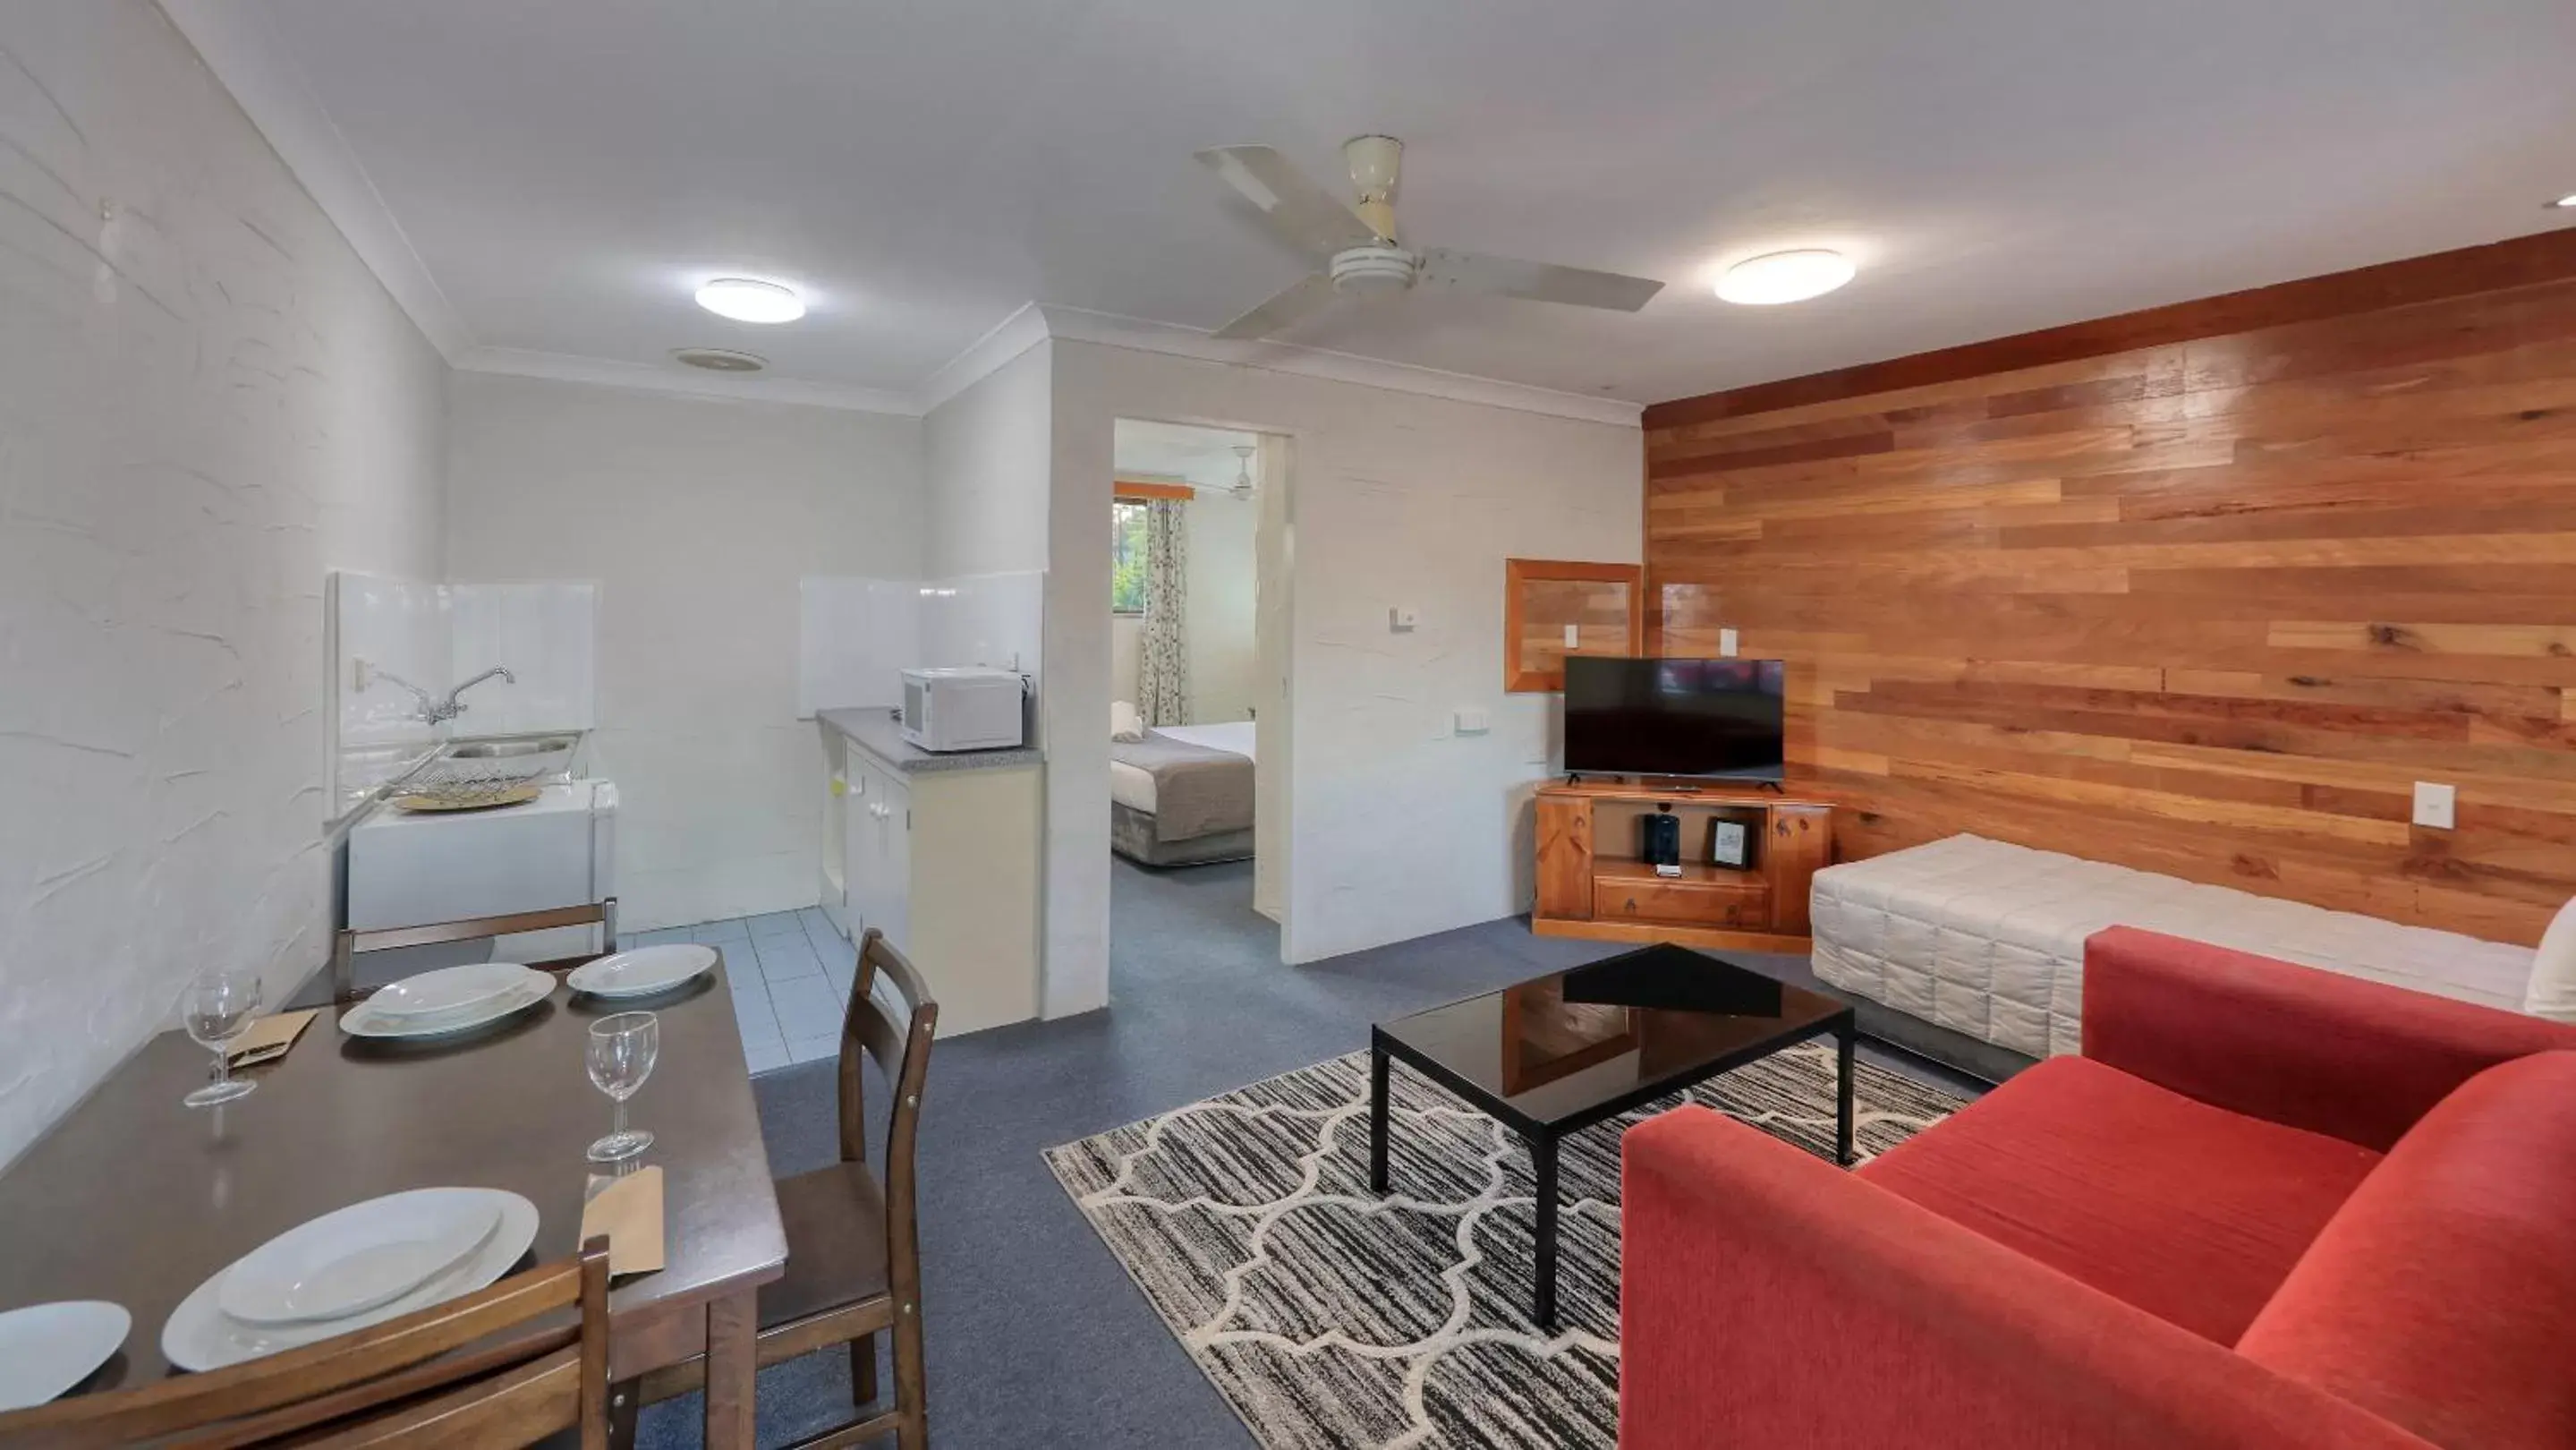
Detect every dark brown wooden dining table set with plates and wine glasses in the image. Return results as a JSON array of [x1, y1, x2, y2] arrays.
[[0, 958, 788, 1450]]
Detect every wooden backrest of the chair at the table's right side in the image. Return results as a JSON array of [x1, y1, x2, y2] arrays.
[[840, 927, 940, 1303]]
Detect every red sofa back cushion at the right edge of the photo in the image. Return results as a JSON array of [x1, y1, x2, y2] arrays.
[[2239, 1051, 2576, 1450]]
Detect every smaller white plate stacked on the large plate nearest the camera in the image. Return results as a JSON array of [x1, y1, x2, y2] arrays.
[[217, 1188, 500, 1324]]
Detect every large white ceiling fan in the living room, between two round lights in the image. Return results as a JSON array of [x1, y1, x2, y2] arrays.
[[1198, 137, 1664, 337]]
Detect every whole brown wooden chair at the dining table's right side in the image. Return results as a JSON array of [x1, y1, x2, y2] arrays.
[[642, 927, 940, 1450]]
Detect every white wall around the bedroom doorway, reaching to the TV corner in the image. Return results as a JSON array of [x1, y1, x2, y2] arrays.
[[1046, 340, 1644, 1015]]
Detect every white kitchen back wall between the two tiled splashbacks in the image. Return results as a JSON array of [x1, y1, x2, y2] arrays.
[[448, 373, 925, 930]]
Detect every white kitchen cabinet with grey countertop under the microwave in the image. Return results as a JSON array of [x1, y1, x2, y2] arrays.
[[820, 711, 1043, 1033]]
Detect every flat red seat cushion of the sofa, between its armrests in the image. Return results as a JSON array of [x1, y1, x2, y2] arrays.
[[1860, 1056, 2380, 1344]]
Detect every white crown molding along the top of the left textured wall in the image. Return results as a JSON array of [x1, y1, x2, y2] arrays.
[[159, 0, 474, 366]]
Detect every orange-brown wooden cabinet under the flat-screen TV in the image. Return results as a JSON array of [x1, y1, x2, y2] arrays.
[[1530, 780, 1834, 953]]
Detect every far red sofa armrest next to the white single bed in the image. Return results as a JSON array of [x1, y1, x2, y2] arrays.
[[2084, 927, 2576, 1154]]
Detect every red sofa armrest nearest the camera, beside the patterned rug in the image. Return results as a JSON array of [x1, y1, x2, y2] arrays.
[[1618, 1107, 2429, 1450]]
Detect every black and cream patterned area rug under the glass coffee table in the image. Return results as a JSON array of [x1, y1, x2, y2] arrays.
[[1046, 1043, 1963, 1450]]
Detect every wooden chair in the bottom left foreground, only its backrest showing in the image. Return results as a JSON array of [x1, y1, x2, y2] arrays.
[[0, 1236, 608, 1450]]
